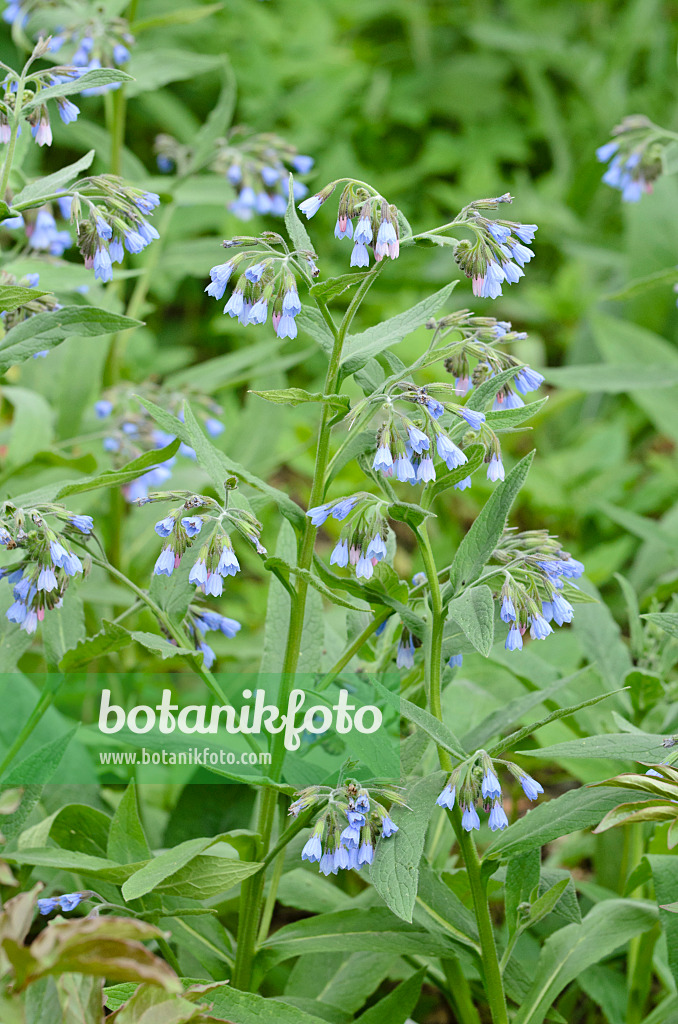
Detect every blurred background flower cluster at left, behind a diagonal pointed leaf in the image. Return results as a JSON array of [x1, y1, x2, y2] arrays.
[[94, 384, 224, 503]]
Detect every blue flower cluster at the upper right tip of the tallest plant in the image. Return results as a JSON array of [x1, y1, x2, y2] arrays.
[[455, 193, 537, 299]]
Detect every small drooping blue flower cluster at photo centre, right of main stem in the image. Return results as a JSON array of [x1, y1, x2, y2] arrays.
[[306, 493, 389, 580]]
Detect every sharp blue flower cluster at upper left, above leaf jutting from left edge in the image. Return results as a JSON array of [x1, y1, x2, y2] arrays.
[[62, 174, 160, 283]]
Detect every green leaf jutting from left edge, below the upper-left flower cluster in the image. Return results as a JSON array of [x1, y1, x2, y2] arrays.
[[0, 306, 139, 374]]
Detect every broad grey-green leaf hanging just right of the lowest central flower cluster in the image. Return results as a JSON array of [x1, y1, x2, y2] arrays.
[[370, 772, 446, 922]]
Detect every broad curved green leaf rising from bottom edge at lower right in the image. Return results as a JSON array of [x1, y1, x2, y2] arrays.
[[514, 899, 656, 1024]]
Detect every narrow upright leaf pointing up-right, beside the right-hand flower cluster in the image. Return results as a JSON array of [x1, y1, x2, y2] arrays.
[[444, 452, 535, 600]]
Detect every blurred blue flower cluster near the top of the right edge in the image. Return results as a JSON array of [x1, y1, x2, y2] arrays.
[[596, 114, 669, 203]]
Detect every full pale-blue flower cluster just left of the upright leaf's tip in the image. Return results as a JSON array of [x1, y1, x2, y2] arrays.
[[372, 383, 485, 489]]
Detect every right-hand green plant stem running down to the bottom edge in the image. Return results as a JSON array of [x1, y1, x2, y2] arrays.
[[417, 521, 508, 1024]]
